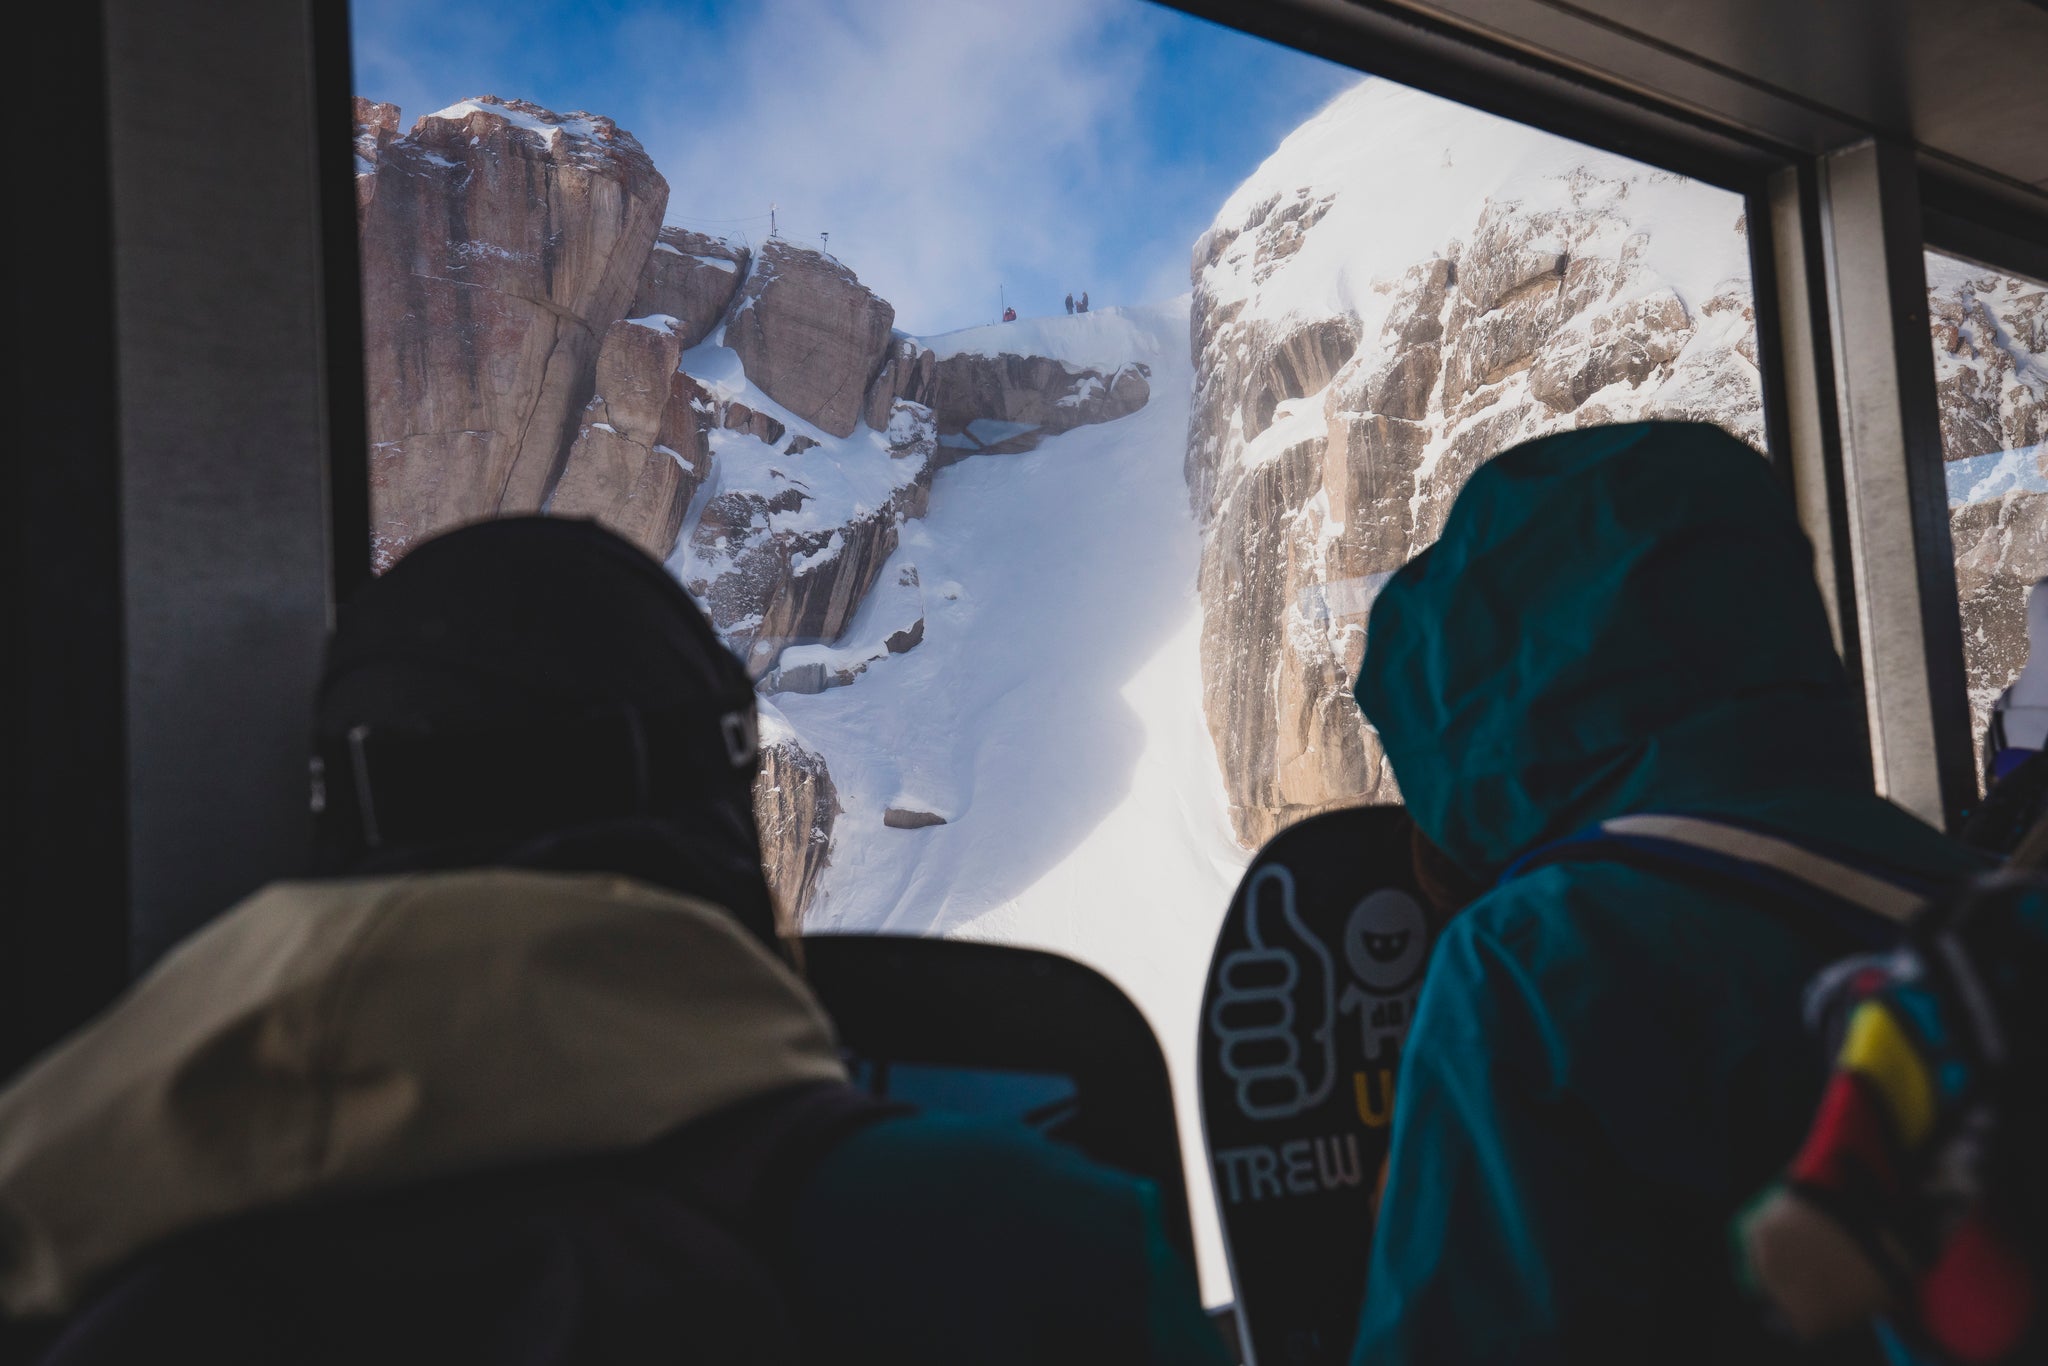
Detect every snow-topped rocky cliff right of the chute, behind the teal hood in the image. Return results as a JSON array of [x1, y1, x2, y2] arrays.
[[1186, 82, 1761, 846]]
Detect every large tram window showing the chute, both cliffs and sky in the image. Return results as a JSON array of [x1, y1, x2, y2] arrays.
[[350, 0, 1761, 1303]]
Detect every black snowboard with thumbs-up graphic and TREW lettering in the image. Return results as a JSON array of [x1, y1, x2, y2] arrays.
[[1200, 807, 1430, 1366]]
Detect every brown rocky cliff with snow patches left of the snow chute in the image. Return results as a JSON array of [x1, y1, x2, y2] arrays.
[[356, 96, 1149, 917]]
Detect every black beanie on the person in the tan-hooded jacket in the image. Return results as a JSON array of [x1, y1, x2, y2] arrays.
[[313, 516, 774, 958]]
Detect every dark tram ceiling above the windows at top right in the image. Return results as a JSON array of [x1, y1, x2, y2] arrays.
[[1178, 0, 2048, 221]]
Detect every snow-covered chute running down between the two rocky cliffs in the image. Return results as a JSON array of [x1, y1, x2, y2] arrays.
[[774, 299, 1245, 1294]]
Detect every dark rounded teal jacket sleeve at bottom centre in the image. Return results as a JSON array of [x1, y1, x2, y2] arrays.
[[795, 1116, 1231, 1366]]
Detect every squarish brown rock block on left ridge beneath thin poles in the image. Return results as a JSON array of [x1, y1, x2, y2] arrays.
[[725, 240, 895, 436]]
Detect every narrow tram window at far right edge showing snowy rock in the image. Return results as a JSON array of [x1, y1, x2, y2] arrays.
[[1927, 252, 2048, 764]]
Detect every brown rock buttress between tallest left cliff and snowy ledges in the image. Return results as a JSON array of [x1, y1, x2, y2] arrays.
[[547, 317, 711, 559]]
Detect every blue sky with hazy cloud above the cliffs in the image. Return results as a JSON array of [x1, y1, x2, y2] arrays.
[[350, 0, 1358, 334]]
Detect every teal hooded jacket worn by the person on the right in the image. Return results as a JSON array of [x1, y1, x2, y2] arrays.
[[1352, 422, 1976, 1366]]
